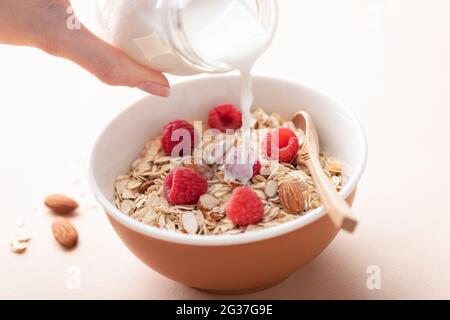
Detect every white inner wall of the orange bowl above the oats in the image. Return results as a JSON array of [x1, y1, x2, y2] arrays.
[[91, 76, 367, 245]]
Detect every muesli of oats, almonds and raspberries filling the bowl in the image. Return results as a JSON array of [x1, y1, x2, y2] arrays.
[[115, 105, 344, 235]]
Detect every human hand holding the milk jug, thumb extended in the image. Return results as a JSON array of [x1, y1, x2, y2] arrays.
[[0, 0, 170, 97]]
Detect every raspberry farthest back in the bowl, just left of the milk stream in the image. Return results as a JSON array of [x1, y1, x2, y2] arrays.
[[208, 104, 242, 132]]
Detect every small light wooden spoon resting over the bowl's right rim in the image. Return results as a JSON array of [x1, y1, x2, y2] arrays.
[[292, 111, 358, 232]]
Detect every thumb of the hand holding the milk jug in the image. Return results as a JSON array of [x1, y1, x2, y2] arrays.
[[58, 26, 170, 97]]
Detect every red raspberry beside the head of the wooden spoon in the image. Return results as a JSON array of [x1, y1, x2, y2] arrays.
[[263, 128, 300, 163]]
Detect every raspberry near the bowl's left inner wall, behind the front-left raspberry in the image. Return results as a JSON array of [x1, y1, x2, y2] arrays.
[[161, 120, 197, 157]]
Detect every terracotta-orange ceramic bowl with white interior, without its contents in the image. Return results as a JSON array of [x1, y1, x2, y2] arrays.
[[90, 76, 367, 294]]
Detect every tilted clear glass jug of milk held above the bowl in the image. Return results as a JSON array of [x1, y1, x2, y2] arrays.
[[98, 0, 278, 75]]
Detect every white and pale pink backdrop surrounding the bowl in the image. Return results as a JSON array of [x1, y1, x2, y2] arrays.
[[0, 0, 450, 299]]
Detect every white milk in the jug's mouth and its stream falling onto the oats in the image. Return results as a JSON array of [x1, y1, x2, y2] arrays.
[[182, 0, 269, 183]]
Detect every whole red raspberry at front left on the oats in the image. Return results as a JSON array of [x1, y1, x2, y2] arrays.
[[164, 168, 208, 205]]
